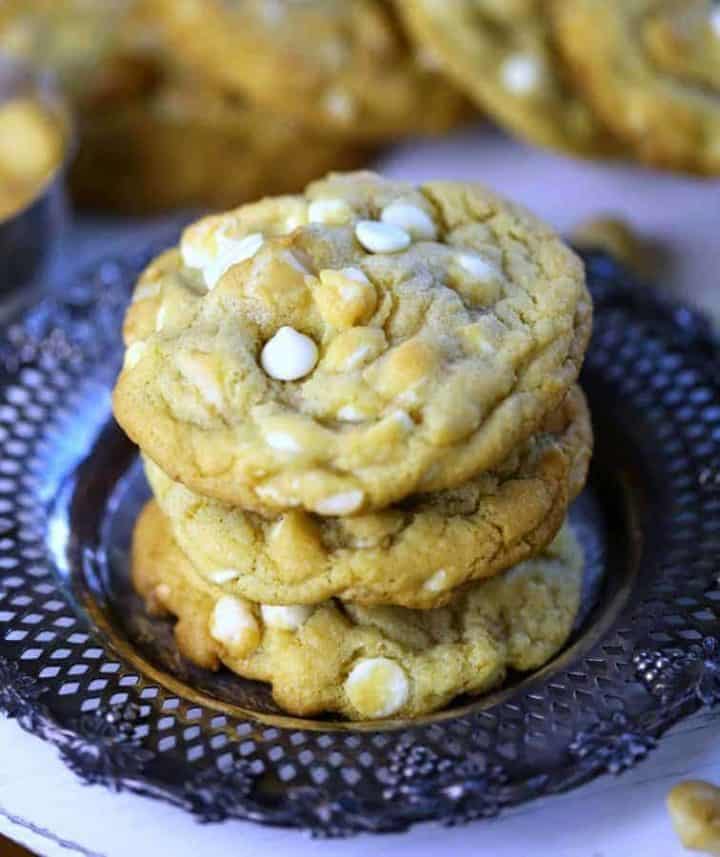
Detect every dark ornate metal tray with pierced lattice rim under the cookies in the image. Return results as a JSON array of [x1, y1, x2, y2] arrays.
[[0, 249, 720, 836]]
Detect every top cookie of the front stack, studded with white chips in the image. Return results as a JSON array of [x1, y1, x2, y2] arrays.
[[114, 173, 591, 515]]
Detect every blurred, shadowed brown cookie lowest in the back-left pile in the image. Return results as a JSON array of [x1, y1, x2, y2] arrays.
[[70, 76, 371, 214]]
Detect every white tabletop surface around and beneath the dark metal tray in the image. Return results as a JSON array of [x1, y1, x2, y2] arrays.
[[0, 129, 720, 857]]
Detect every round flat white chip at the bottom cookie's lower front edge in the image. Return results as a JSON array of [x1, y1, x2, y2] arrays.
[[345, 658, 410, 719]]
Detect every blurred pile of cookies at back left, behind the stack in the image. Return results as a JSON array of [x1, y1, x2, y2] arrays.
[[0, 0, 470, 214]]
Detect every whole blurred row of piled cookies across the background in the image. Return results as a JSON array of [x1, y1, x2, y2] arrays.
[[0, 0, 720, 221]]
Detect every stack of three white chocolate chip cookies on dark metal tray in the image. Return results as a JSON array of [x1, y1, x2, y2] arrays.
[[114, 173, 592, 719]]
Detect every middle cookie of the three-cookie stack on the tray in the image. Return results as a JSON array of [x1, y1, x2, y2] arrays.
[[146, 388, 592, 609]]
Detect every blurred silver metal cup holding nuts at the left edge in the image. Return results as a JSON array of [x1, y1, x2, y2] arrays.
[[0, 57, 73, 295]]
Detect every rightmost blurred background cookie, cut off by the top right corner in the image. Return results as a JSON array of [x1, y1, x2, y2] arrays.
[[553, 0, 720, 174]]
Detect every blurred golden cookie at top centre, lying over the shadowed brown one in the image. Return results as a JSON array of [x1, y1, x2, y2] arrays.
[[149, 0, 468, 140]]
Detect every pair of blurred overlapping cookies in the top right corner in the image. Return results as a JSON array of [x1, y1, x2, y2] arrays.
[[395, 0, 720, 175]]
